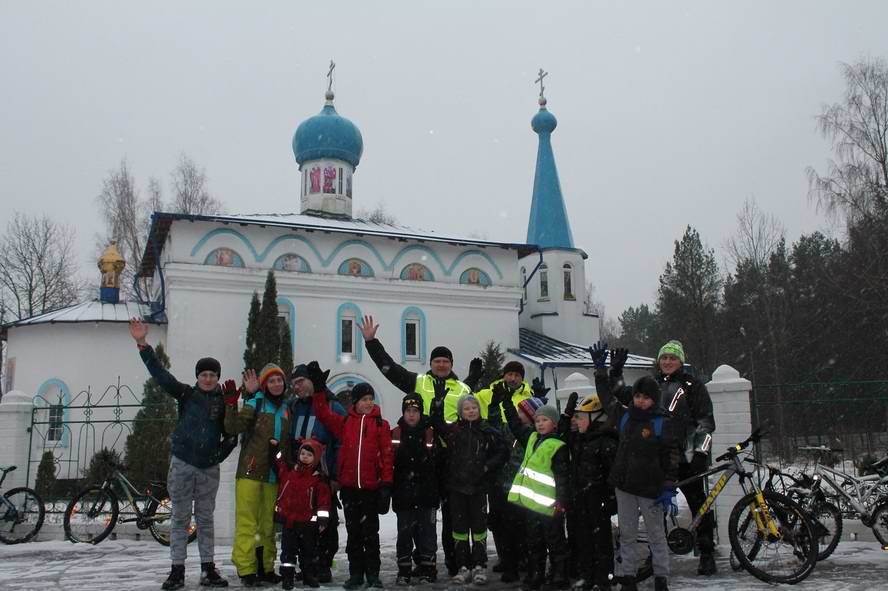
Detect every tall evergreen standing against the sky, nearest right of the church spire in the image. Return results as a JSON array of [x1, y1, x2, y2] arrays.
[[657, 226, 722, 377]]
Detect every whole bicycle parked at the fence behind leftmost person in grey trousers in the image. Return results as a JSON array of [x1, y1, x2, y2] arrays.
[[64, 466, 197, 546]]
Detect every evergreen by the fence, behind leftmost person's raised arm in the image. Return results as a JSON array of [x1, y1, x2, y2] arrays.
[[125, 345, 178, 490]]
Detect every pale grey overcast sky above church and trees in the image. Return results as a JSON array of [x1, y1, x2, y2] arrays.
[[0, 0, 888, 316]]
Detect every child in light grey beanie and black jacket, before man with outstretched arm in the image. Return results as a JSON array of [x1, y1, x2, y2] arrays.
[[432, 389, 509, 585]]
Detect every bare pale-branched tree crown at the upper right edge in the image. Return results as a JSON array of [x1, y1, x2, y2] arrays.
[[808, 58, 888, 223]]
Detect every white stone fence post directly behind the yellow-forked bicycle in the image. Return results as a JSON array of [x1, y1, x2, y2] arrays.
[[706, 365, 752, 543]]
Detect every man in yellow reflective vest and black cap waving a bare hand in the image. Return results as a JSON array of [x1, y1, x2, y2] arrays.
[[360, 316, 482, 576]]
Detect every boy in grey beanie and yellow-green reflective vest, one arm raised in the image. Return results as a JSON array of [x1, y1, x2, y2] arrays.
[[491, 383, 570, 590]]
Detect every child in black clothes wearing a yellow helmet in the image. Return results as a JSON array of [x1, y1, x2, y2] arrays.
[[558, 392, 617, 591]]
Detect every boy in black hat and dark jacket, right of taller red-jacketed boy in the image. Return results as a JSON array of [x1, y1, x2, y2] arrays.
[[392, 394, 439, 585]]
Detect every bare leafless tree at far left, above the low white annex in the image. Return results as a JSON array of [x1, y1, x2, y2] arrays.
[[0, 213, 84, 320]]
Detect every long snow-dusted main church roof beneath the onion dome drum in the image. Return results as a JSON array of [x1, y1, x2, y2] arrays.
[[140, 212, 538, 277]]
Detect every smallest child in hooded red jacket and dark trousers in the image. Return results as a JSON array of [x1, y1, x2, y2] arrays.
[[275, 439, 331, 589]]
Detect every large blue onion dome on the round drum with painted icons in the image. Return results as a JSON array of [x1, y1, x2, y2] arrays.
[[293, 92, 364, 168]]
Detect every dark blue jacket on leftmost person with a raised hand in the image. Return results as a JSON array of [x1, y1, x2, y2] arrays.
[[139, 346, 231, 468]]
